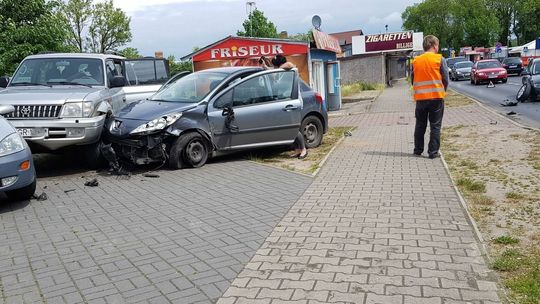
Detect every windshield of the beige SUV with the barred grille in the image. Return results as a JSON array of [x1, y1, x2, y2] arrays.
[[10, 58, 104, 86]]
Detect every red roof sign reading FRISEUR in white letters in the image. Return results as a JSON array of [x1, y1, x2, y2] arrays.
[[193, 38, 309, 61]]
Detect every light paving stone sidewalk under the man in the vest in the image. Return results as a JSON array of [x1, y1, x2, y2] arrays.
[[218, 83, 500, 304]]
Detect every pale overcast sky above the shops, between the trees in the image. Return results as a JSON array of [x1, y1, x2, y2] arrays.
[[110, 0, 419, 58]]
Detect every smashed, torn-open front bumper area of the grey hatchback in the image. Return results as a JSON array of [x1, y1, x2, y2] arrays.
[[106, 134, 168, 165]]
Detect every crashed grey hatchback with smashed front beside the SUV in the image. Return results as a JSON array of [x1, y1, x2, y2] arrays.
[[104, 67, 328, 169]]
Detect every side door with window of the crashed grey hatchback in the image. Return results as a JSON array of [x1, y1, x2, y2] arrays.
[[208, 70, 302, 150]]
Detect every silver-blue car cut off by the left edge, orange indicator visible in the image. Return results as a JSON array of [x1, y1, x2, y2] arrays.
[[0, 105, 36, 201]]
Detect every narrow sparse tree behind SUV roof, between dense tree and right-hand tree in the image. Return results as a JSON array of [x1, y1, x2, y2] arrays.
[[62, 0, 93, 52]]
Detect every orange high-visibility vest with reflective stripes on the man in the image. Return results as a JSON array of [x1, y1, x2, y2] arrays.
[[413, 52, 446, 101]]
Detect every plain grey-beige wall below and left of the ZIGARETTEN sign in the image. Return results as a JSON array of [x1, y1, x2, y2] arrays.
[[339, 54, 386, 84]]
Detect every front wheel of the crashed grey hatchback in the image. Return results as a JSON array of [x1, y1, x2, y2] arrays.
[[169, 132, 209, 169]]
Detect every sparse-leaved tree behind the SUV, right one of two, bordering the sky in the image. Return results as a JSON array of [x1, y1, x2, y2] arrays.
[[86, 0, 131, 53]]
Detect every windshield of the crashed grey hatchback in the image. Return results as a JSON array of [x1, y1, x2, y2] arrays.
[[151, 72, 228, 103]]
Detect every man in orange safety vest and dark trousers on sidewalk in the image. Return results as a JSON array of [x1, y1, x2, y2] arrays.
[[411, 35, 449, 159]]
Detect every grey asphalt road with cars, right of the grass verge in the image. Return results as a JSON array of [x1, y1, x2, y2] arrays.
[[450, 76, 540, 128]]
